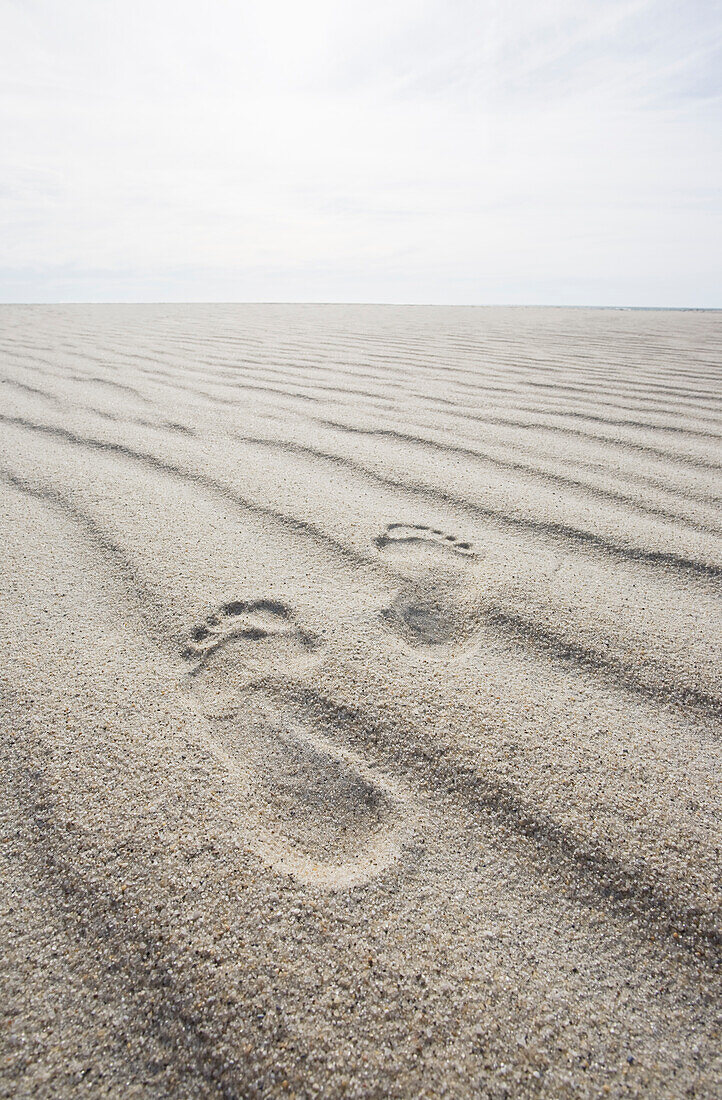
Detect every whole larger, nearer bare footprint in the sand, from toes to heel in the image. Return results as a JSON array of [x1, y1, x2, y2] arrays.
[[183, 600, 414, 889]]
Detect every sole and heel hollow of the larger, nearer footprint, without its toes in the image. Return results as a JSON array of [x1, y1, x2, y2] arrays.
[[204, 690, 417, 889]]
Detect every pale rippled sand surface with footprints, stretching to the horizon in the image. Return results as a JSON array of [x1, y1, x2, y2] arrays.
[[0, 306, 722, 1100]]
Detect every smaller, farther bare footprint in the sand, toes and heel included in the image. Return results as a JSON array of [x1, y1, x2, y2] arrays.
[[374, 524, 482, 658]]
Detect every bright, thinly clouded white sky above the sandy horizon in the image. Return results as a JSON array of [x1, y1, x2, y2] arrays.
[[0, 0, 722, 307]]
